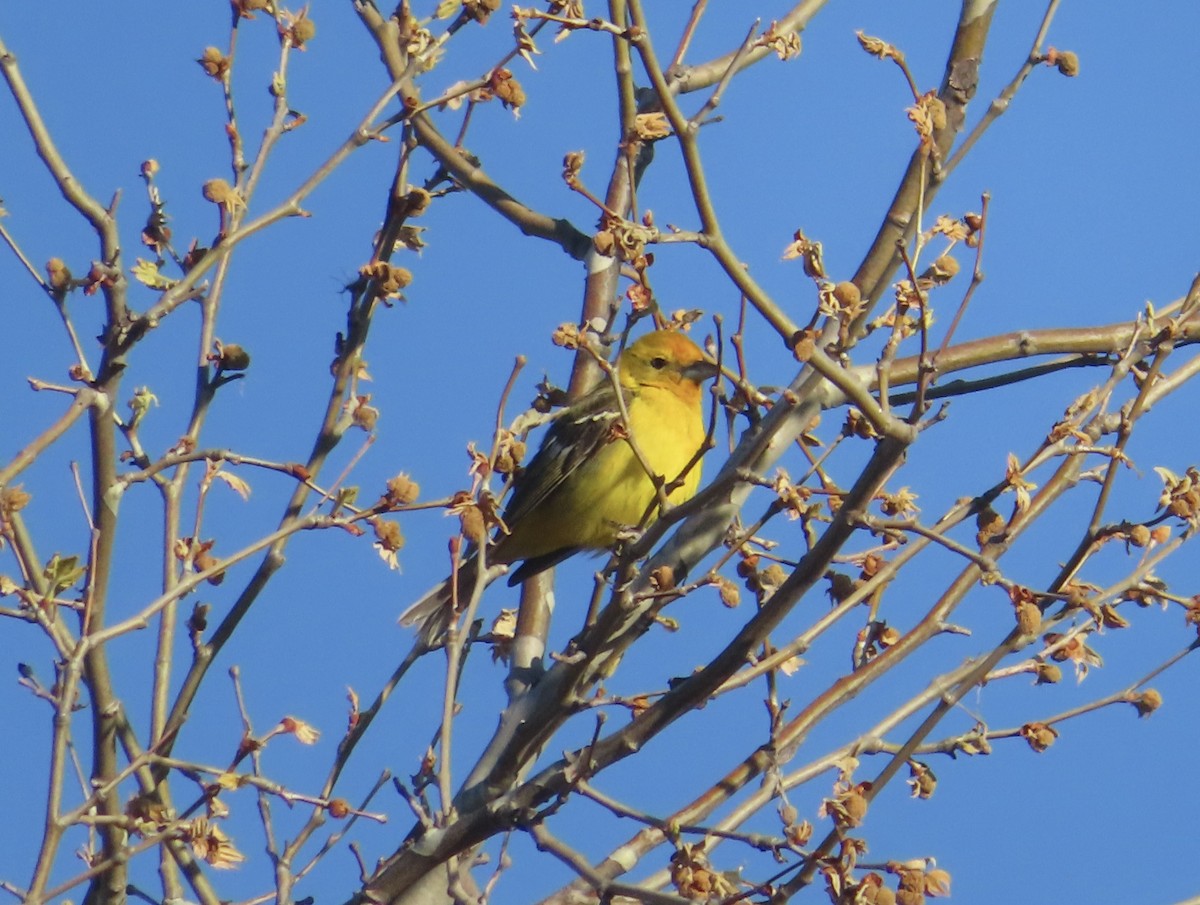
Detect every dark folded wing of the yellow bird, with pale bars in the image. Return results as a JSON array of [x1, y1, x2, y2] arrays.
[[503, 382, 630, 526]]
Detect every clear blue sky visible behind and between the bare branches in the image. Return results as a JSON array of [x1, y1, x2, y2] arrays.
[[0, 0, 1200, 905]]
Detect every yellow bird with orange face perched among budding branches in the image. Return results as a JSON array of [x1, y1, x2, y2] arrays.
[[400, 330, 718, 648]]
